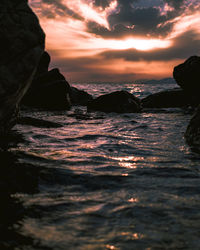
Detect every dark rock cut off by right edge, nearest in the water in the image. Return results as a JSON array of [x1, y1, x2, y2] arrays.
[[185, 106, 200, 149]]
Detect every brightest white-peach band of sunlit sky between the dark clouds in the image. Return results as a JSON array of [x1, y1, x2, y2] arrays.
[[43, 17, 172, 54]]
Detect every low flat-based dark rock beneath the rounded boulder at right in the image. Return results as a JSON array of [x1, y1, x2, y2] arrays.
[[141, 88, 195, 108]]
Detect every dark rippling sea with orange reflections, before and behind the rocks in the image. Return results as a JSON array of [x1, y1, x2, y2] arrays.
[[0, 79, 200, 250]]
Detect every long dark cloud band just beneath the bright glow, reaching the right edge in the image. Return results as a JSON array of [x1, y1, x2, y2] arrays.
[[101, 31, 200, 62]]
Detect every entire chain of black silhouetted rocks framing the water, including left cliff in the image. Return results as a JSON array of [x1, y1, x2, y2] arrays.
[[0, 0, 200, 150]]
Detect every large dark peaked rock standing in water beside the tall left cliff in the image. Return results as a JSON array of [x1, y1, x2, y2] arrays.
[[22, 69, 71, 110]]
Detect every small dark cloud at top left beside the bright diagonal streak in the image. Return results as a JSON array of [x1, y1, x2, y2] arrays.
[[41, 0, 83, 20]]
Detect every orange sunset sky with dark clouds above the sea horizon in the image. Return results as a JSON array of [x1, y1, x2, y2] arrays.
[[29, 0, 200, 83]]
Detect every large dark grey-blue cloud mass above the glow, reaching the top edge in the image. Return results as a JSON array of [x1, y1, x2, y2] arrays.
[[87, 0, 195, 38]]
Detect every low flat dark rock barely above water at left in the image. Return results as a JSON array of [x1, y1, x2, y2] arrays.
[[17, 116, 63, 128]]
